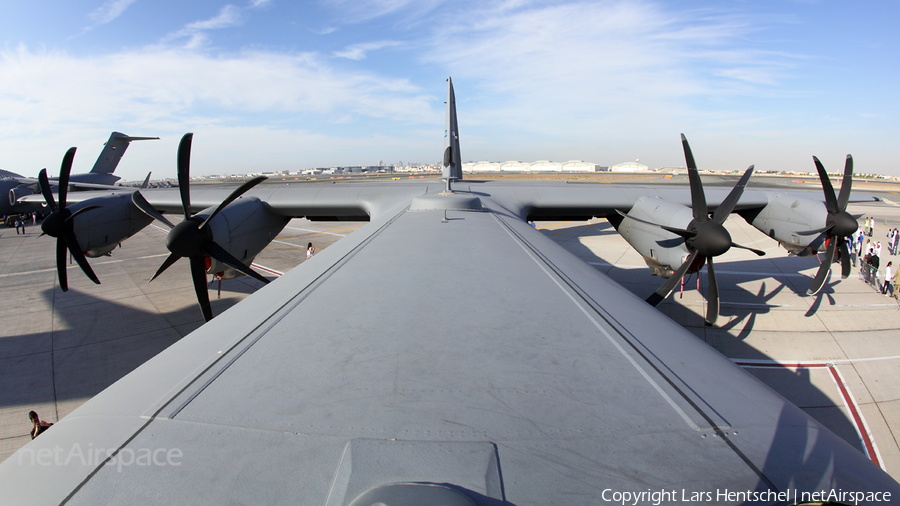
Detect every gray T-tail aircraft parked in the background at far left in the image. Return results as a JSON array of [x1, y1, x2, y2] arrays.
[[0, 132, 159, 216]]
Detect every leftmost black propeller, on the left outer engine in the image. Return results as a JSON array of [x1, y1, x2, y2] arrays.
[[38, 148, 100, 292]]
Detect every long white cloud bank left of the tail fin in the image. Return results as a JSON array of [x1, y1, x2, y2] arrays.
[[0, 48, 441, 179]]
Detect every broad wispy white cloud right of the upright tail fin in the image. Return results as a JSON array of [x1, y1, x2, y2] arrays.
[[423, 1, 808, 159]]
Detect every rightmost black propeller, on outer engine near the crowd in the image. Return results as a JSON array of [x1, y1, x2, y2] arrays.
[[797, 155, 859, 295]]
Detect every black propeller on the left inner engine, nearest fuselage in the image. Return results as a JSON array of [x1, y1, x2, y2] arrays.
[[142, 133, 269, 321]]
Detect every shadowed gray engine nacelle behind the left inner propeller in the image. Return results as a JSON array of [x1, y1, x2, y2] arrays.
[[198, 196, 290, 279]]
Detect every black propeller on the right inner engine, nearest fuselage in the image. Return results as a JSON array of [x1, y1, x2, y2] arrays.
[[625, 134, 765, 325]]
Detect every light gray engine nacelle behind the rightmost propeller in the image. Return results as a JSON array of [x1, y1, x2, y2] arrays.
[[741, 193, 828, 256]]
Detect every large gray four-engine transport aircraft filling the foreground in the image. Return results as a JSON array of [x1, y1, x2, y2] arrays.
[[0, 81, 900, 506]]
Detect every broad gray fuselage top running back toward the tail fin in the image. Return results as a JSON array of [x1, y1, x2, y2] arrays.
[[0, 185, 897, 505]]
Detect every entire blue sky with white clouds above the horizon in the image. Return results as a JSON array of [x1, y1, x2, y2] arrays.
[[0, 0, 900, 180]]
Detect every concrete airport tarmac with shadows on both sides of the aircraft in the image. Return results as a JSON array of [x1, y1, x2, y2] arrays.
[[0, 197, 900, 479]]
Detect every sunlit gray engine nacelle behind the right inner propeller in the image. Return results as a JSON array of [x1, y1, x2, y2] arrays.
[[614, 197, 694, 278]]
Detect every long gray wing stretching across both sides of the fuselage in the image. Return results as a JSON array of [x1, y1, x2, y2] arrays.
[[31, 180, 879, 221]]
